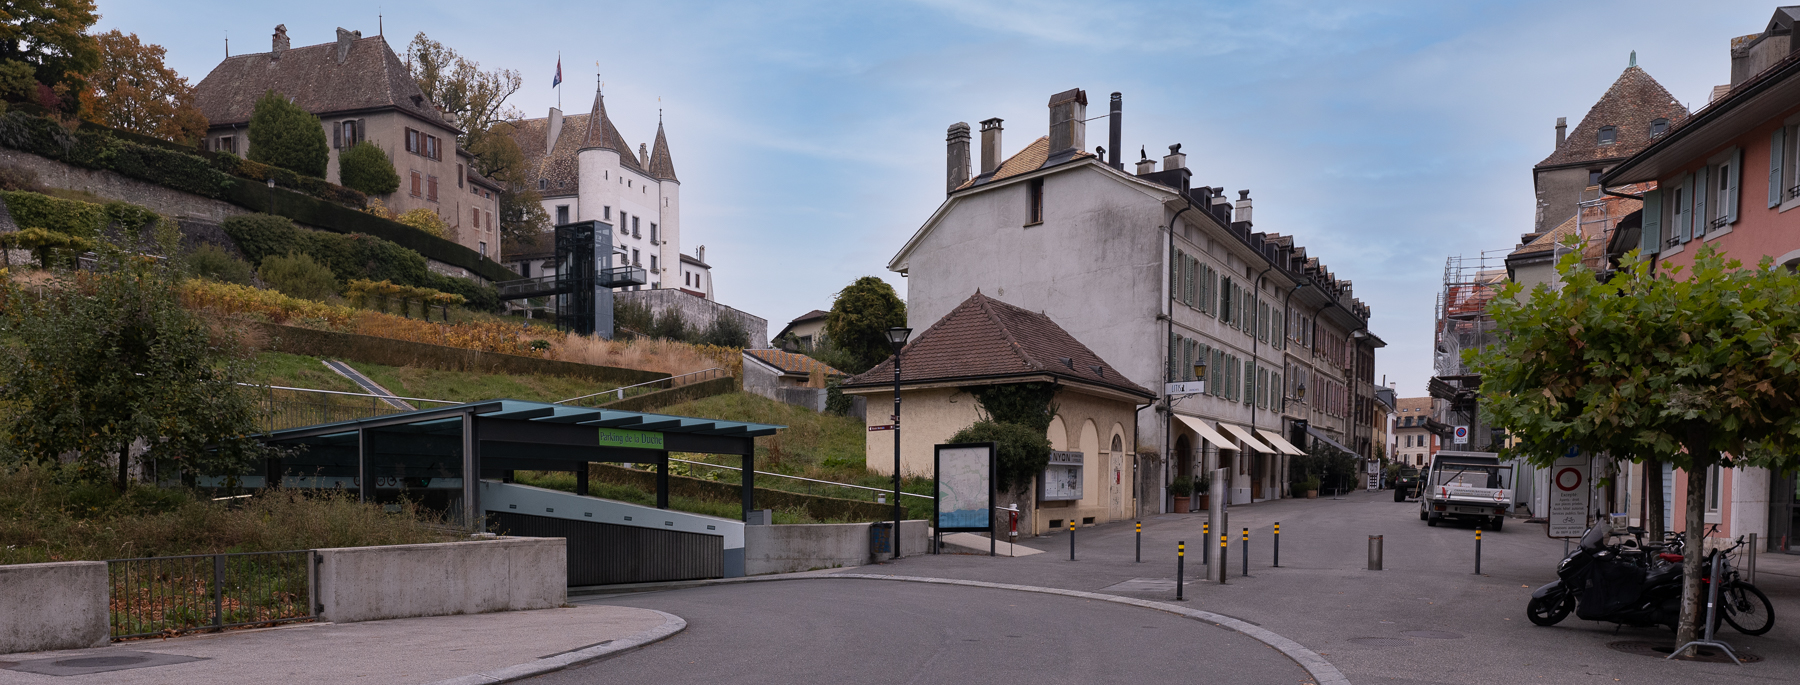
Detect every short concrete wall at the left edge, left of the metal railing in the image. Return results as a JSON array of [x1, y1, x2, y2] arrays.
[[0, 561, 112, 654]]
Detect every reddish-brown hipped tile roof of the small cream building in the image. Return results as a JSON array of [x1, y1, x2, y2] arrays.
[[844, 291, 1156, 397]]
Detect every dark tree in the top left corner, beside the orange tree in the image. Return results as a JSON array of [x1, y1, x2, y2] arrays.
[[0, 0, 101, 113]]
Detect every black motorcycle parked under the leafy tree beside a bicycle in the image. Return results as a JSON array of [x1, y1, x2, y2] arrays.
[[1525, 525, 1681, 629]]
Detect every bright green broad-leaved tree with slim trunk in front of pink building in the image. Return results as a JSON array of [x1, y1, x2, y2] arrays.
[[1463, 245, 1800, 654]]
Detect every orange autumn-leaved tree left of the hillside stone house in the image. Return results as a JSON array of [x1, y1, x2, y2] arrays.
[[81, 29, 207, 144]]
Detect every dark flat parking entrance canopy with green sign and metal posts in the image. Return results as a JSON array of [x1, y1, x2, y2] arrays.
[[259, 399, 787, 523]]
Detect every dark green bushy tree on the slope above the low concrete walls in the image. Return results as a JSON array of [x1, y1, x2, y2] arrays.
[[0, 219, 263, 489]]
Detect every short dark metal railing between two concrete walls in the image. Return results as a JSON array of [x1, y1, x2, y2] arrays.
[[106, 550, 319, 640]]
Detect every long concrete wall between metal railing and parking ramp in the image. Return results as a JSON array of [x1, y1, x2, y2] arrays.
[[318, 538, 569, 624]]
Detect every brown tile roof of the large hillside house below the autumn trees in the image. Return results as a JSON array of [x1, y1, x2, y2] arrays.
[[194, 34, 455, 131]]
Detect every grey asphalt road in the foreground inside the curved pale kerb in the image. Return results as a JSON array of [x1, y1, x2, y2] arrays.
[[547, 579, 1310, 685]]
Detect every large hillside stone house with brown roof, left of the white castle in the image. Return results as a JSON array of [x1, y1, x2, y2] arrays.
[[194, 25, 500, 259]]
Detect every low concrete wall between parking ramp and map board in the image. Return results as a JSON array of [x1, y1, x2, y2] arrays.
[[743, 521, 931, 575]]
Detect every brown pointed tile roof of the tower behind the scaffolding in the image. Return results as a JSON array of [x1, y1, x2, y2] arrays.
[[1537, 67, 1688, 167]]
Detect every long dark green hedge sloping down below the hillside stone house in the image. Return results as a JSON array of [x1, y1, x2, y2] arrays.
[[0, 111, 518, 282]]
